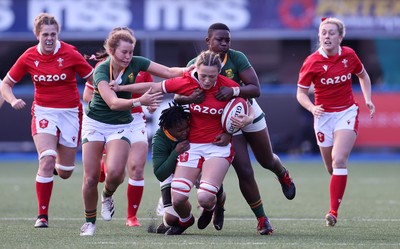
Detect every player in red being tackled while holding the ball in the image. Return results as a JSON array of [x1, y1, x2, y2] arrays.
[[112, 51, 258, 235]]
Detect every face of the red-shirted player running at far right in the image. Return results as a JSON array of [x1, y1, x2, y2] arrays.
[[318, 23, 343, 55]]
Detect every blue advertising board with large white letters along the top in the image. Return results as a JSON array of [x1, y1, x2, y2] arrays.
[[0, 0, 400, 40]]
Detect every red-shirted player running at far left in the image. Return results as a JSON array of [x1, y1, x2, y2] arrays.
[[1, 13, 93, 227]]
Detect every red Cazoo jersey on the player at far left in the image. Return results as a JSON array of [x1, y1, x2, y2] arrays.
[[7, 41, 93, 108]]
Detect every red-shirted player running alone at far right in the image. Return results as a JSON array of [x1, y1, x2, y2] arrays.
[[297, 18, 375, 226]]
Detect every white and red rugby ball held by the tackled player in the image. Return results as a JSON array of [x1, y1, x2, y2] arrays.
[[221, 97, 249, 134]]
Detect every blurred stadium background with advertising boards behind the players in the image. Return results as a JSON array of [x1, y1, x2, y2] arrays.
[[0, 0, 400, 154]]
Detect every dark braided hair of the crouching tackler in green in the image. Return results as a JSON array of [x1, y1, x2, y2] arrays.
[[158, 101, 190, 130]]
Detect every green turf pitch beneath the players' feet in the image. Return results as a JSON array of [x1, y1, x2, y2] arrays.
[[0, 161, 400, 249]]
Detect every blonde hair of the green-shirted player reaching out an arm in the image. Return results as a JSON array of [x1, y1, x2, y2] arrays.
[[104, 27, 136, 55]]
